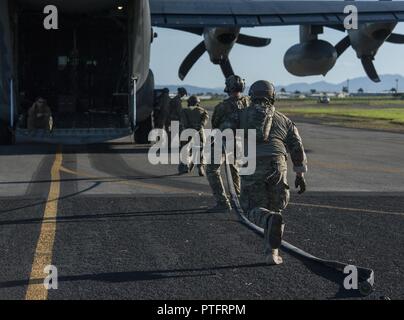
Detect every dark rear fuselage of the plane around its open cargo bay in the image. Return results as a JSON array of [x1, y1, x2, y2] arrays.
[[0, 0, 154, 144]]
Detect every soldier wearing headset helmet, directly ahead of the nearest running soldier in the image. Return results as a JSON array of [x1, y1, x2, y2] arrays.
[[206, 75, 249, 212]]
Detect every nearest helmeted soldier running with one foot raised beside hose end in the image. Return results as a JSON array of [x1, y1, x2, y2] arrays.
[[240, 81, 307, 264]]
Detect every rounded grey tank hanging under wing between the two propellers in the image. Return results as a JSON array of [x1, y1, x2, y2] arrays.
[[283, 40, 338, 77]]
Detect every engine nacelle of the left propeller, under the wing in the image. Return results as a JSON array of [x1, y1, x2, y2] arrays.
[[203, 28, 240, 64]]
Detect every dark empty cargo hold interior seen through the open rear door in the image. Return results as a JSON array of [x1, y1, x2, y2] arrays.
[[15, 12, 129, 128]]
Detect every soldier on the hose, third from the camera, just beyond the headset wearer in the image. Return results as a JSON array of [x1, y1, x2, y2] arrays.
[[179, 96, 209, 177]]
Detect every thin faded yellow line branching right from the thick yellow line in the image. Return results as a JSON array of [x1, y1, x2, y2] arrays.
[[61, 167, 207, 195]]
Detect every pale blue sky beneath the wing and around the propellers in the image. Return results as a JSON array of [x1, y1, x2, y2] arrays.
[[151, 23, 404, 88]]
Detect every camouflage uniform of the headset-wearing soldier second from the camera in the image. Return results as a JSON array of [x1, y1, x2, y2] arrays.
[[206, 97, 249, 206]]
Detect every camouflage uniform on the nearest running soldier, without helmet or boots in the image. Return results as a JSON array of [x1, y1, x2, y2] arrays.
[[240, 105, 307, 212]]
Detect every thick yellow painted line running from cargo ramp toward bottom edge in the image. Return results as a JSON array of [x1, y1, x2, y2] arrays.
[[25, 148, 63, 300]]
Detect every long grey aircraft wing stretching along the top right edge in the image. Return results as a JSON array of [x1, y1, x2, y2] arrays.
[[150, 0, 404, 28]]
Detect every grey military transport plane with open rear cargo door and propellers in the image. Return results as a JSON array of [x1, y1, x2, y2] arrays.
[[0, 0, 404, 144]]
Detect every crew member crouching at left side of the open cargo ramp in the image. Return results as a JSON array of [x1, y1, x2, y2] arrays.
[[27, 97, 53, 132]]
